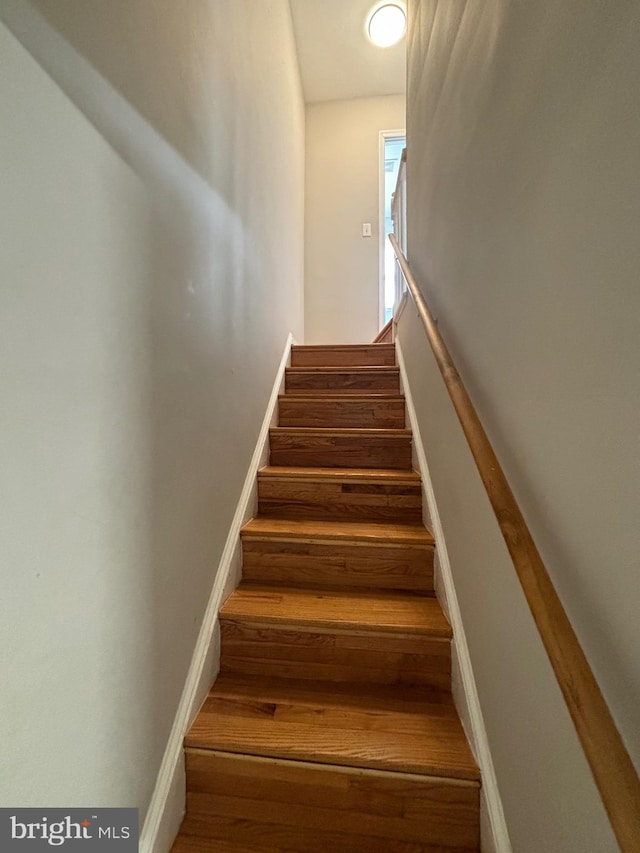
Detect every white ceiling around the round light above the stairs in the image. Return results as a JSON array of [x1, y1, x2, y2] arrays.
[[289, 0, 406, 103]]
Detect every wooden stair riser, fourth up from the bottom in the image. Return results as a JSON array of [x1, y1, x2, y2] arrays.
[[258, 477, 422, 524]]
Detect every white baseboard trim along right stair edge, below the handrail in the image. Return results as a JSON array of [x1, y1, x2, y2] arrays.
[[395, 339, 512, 853]]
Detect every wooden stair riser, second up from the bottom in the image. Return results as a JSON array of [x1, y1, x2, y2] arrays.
[[220, 617, 451, 690]]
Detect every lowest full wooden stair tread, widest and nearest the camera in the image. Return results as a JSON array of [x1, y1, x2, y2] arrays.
[[185, 675, 479, 782]]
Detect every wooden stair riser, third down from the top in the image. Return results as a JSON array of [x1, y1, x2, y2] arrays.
[[279, 395, 405, 429]]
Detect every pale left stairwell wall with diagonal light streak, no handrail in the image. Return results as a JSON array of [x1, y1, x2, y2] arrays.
[[0, 0, 304, 817]]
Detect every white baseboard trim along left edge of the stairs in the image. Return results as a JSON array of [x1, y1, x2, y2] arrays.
[[139, 334, 293, 853]]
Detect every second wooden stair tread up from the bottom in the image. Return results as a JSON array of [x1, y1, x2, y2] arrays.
[[220, 583, 451, 640]]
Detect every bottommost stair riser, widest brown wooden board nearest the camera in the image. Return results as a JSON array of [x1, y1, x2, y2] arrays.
[[184, 750, 479, 853]]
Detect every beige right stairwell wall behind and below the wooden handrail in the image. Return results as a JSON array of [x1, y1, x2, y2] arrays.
[[400, 0, 640, 853]]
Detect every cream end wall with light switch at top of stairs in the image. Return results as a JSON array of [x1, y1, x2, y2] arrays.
[[305, 95, 405, 344]]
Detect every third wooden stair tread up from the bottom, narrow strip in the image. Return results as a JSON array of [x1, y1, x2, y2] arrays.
[[241, 516, 434, 548]]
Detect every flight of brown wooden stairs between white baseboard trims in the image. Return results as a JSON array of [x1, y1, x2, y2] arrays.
[[173, 344, 480, 853]]
